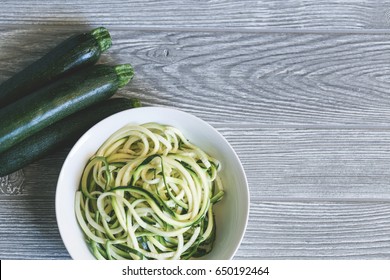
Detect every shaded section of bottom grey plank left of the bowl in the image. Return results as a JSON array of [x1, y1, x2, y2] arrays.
[[0, 196, 70, 260]]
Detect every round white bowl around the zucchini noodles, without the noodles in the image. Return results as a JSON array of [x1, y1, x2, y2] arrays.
[[56, 107, 249, 260]]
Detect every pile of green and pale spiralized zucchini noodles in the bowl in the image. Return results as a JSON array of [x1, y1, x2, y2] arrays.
[[75, 123, 224, 259]]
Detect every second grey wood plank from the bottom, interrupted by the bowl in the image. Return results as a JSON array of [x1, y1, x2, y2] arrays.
[[3, 127, 390, 199]]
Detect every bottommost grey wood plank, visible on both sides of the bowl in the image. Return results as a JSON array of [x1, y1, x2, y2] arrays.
[[0, 197, 390, 259]]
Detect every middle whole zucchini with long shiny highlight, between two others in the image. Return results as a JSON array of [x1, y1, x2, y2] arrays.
[[0, 64, 134, 153]]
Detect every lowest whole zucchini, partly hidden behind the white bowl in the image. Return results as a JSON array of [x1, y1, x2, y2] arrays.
[[0, 98, 140, 177]]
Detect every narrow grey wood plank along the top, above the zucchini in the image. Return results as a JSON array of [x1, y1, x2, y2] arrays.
[[0, 0, 389, 30]]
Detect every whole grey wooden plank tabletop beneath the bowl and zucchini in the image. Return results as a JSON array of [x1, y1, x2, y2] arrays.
[[0, 0, 390, 259]]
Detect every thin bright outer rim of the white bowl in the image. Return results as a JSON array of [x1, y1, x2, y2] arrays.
[[55, 106, 250, 259]]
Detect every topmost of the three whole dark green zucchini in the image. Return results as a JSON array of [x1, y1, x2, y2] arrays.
[[0, 27, 112, 108]]
